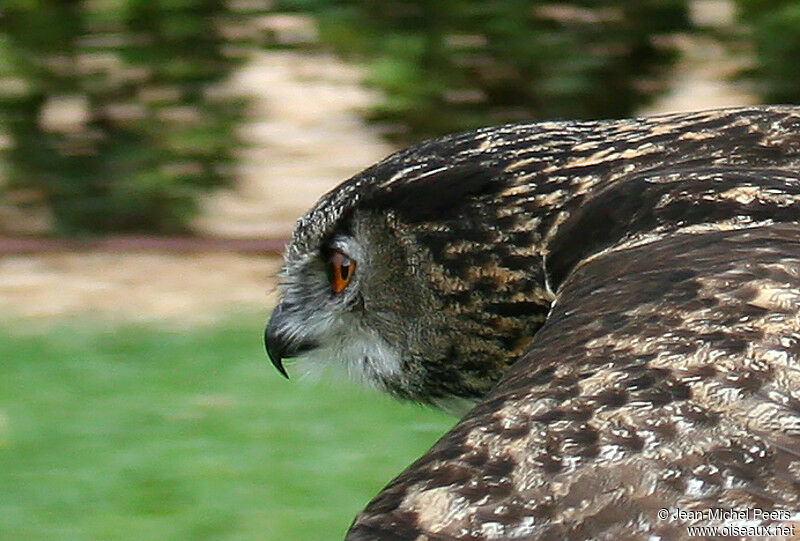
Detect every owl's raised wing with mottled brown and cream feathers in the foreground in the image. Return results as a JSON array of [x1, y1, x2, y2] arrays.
[[348, 218, 800, 540]]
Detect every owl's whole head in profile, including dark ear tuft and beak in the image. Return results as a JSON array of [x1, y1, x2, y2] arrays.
[[265, 131, 552, 409]]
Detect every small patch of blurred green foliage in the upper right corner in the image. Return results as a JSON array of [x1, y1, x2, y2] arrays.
[[736, 0, 800, 103]]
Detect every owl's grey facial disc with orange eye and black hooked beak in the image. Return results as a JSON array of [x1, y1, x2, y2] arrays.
[[265, 211, 460, 408]]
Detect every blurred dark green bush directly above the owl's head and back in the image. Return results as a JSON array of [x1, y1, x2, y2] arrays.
[[275, 0, 689, 142]]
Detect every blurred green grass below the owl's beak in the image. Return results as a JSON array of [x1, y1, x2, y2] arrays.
[[0, 315, 455, 540]]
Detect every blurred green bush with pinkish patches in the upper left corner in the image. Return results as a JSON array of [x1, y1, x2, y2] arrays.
[[0, 0, 264, 233]]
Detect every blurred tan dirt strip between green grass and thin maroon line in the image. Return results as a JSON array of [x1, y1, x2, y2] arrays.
[[0, 253, 280, 324]]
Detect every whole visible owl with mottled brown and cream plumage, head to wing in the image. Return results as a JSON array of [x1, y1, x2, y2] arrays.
[[266, 106, 800, 539]]
